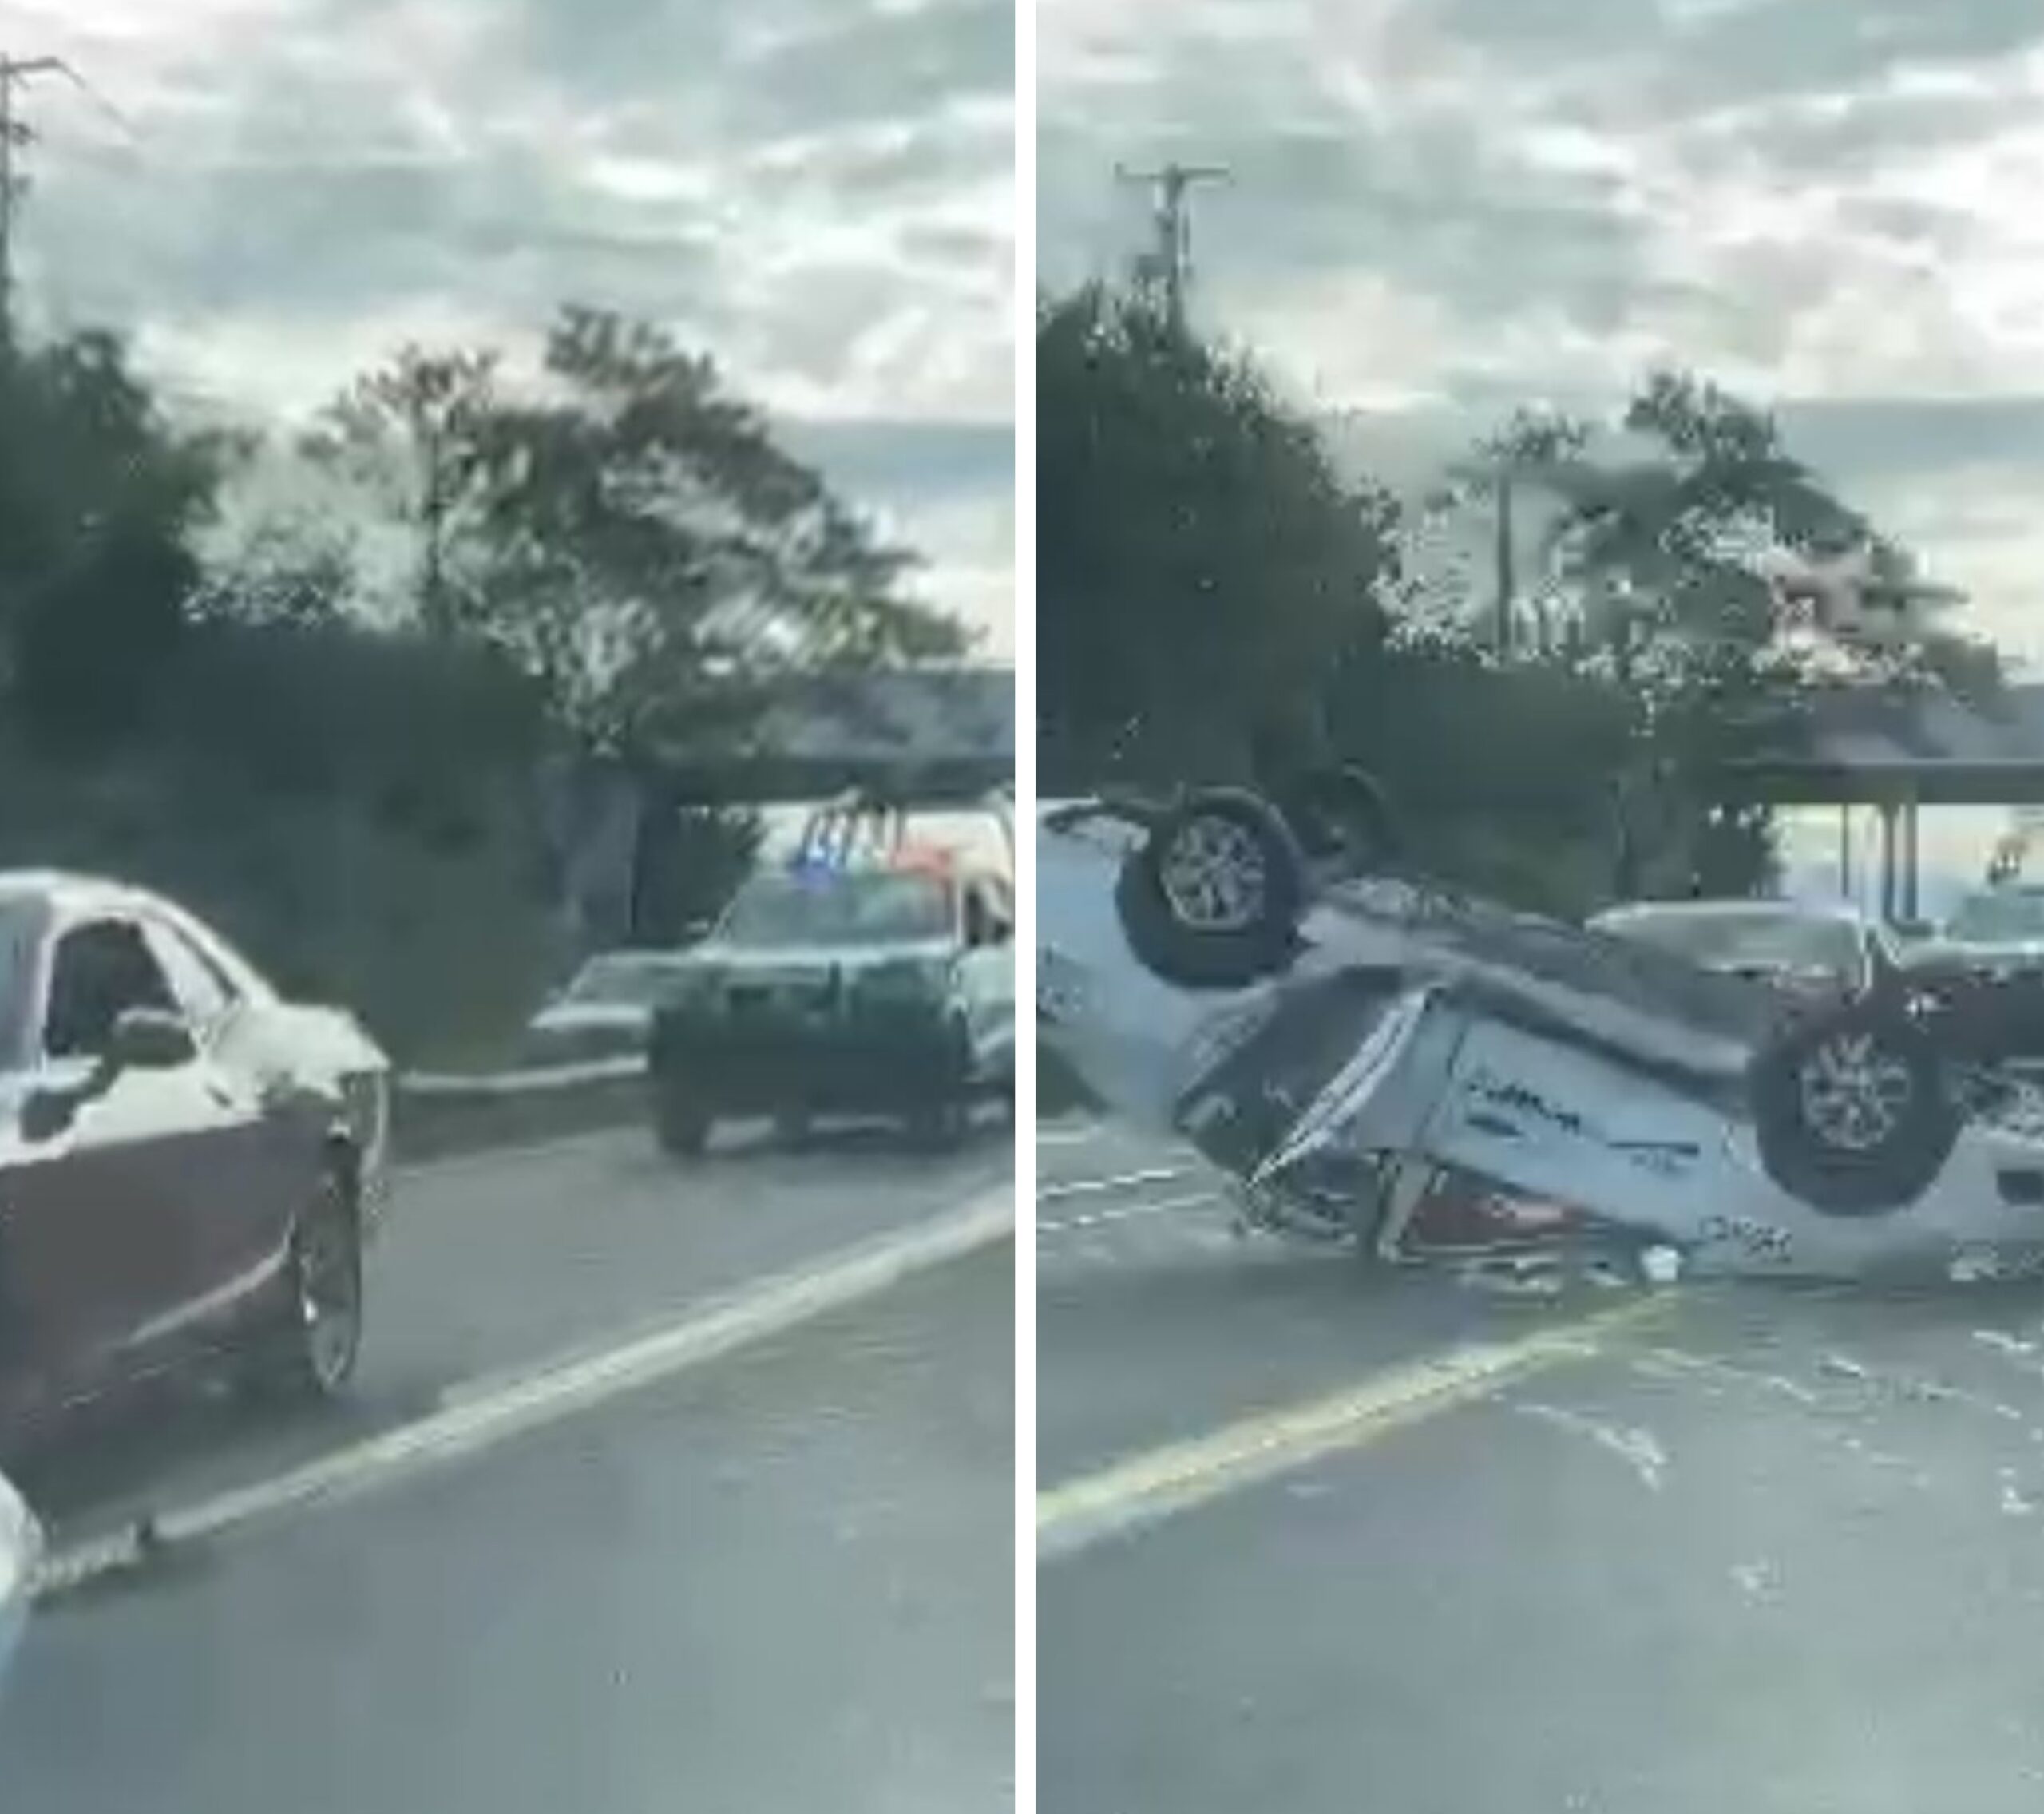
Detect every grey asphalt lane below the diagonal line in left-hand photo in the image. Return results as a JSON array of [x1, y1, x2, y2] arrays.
[[0, 1250, 1014, 1814]]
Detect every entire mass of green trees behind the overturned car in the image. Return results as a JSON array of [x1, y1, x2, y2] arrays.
[[1036, 277, 1999, 909]]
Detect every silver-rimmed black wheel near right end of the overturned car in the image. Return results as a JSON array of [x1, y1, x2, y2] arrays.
[[1748, 999, 1963, 1215]]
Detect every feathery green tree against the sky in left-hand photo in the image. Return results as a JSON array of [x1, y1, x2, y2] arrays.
[[329, 308, 965, 752]]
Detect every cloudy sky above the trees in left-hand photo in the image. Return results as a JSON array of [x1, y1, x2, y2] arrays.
[[0, 0, 1016, 652]]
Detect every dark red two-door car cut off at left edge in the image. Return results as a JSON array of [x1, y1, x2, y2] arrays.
[[0, 873, 390, 1444]]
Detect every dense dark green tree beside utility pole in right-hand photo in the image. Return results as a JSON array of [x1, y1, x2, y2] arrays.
[[1036, 288, 1396, 784]]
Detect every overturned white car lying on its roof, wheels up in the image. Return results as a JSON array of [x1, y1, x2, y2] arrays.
[[1036, 776, 2044, 1279]]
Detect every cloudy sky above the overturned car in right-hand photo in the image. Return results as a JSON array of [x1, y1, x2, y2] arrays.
[[1038, 0, 2044, 658]]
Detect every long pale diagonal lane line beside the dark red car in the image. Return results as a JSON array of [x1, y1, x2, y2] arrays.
[[35, 1187, 1016, 1599]]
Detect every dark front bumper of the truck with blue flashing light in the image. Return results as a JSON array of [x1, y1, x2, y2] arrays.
[[652, 1011, 973, 1113]]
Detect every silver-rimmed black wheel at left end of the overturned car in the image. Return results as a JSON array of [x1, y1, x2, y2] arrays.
[[1114, 789, 1306, 988]]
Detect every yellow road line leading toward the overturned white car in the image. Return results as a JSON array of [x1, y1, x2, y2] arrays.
[[1036, 1295, 1668, 1562]]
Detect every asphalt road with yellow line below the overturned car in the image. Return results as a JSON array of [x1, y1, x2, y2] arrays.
[[1036, 1127, 2044, 1814]]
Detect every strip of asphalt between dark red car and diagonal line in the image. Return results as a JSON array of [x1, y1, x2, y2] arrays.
[[21, 1123, 1014, 1543]]
